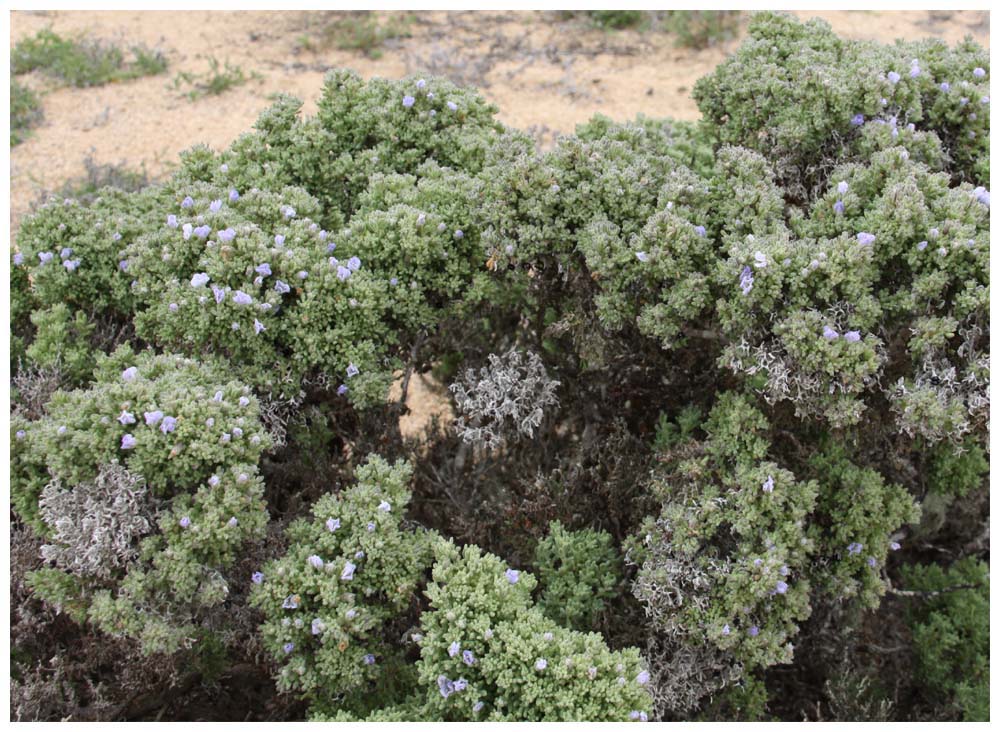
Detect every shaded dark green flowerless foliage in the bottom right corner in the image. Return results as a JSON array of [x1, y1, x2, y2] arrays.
[[903, 557, 990, 722]]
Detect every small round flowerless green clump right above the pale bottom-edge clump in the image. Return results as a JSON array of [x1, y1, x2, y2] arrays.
[[534, 521, 621, 630]]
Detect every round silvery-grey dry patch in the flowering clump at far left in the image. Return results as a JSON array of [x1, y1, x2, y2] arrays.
[[38, 465, 152, 577]]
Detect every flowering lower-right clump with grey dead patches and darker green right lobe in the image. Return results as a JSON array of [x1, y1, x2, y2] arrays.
[[629, 394, 919, 692]]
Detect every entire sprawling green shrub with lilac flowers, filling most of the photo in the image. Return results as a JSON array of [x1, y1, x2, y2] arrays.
[[10, 13, 990, 721]]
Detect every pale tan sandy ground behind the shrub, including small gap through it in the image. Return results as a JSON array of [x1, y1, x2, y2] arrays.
[[10, 11, 989, 432]]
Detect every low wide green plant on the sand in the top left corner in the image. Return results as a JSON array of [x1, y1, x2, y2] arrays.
[[11, 28, 167, 87]]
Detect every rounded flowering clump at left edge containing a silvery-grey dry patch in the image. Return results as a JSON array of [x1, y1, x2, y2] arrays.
[[11, 347, 269, 652]]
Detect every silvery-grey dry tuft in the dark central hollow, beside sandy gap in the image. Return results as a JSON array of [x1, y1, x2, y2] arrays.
[[450, 348, 559, 449]]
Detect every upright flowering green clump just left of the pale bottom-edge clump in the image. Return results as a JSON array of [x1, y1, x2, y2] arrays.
[[250, 456, 434, 713]]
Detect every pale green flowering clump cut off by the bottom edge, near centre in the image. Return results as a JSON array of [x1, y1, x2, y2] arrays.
[[372, 542, 649, 721]]
